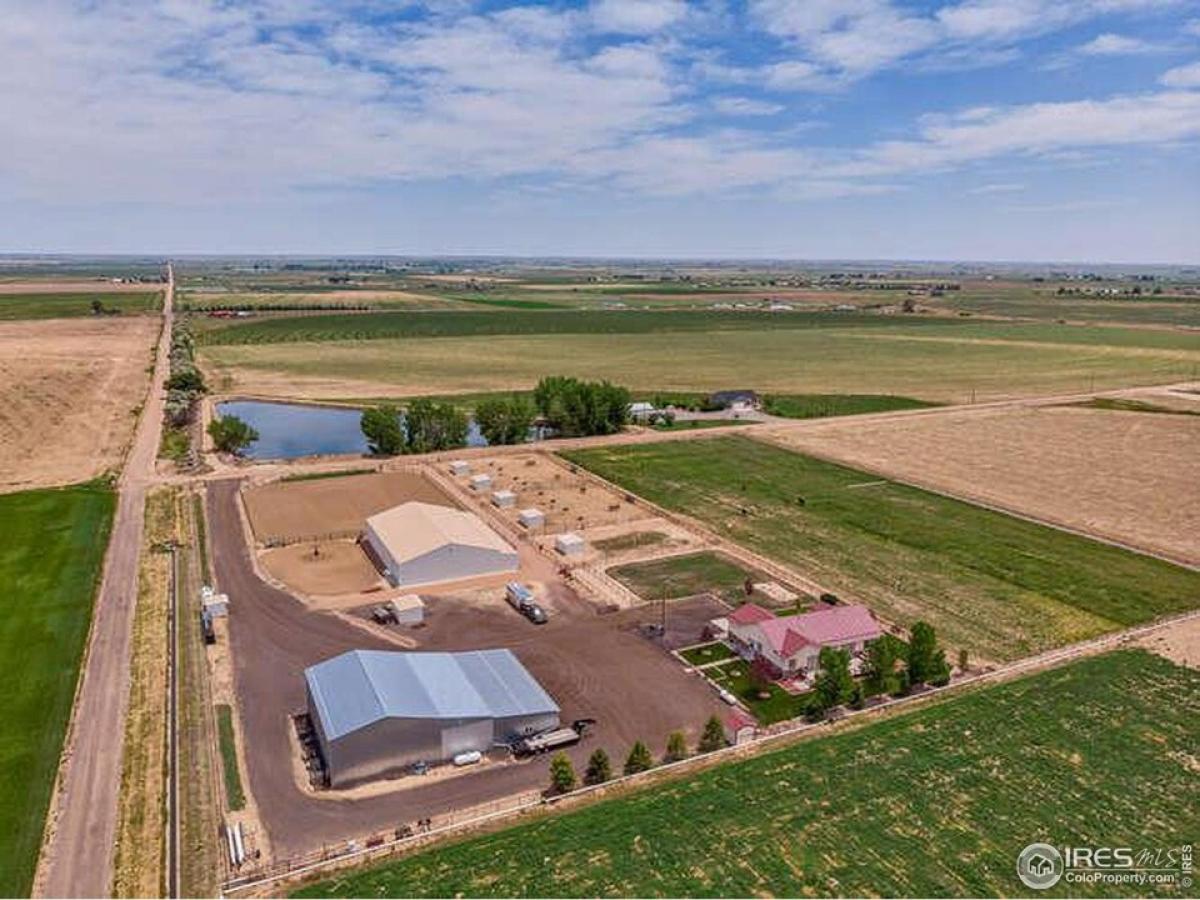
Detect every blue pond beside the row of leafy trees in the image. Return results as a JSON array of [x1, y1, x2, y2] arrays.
[[217, 400, 487, 460]]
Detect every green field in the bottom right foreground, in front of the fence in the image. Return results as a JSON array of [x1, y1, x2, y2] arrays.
[[294, 650, 1200, 896]]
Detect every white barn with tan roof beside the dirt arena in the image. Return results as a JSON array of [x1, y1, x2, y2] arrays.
[[362, 500, 518, 587]]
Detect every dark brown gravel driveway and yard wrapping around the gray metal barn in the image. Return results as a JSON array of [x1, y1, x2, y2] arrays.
[[208, 479, 725, 857]]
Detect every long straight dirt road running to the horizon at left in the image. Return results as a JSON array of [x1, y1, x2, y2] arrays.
[[34, 266, 174, 898]]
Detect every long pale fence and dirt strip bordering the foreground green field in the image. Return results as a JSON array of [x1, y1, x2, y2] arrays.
[[222, 610, 1200, 896]]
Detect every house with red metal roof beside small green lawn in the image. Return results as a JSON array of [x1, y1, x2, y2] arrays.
[[728, 604, 883, 678]]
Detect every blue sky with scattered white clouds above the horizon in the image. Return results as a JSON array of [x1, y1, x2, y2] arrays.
[[0, 0, 1200, 263]]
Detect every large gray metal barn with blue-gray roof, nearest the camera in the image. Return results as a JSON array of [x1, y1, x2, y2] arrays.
[[305, 649, 558, 787]]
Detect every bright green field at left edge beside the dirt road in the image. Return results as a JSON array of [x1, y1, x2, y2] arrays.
[[0, 485, 115, 896]]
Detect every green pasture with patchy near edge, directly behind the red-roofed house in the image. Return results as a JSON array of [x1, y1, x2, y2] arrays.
[[564, 437, 1200, 660]]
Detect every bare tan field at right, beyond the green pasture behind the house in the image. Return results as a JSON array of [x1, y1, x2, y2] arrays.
[[770, 406, 1200, 564]]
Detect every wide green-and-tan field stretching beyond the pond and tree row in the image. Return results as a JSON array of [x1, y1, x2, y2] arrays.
[[192, 312, 1200, 402]]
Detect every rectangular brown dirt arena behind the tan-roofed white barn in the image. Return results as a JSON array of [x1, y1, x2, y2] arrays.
[[242, 472, 456, 545]]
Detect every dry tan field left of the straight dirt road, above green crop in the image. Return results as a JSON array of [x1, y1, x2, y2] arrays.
[[0, 317, 160, 491]]
